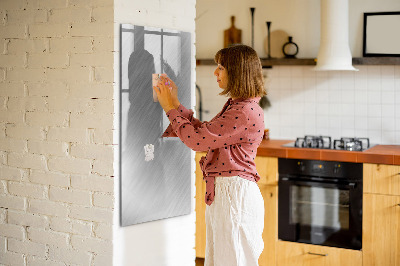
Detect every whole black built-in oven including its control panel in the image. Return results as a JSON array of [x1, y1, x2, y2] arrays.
[[278, 158, 363, 250]]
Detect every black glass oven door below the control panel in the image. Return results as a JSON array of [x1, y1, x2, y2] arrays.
[[278, 176, 362, 250]]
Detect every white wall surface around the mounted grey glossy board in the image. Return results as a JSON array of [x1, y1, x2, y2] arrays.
[[114, 0, 196, 266]]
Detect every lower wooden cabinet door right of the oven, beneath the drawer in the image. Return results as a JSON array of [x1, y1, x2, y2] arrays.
[[363, 194, 400, 266]]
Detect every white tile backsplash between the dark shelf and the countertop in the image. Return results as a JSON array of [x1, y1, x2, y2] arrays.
[[196, 65, 400, 144]]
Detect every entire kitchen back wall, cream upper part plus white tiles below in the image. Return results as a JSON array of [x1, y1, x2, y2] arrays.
[[196, 0, 400, 144]]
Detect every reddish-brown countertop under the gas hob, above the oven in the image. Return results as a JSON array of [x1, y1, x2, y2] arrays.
[[257, 140, 400, 165]]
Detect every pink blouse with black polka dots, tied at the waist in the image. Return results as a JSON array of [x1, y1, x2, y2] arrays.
[[161, 97, 265, 205]]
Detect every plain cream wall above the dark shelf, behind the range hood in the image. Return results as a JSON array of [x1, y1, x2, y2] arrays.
[[196, 0, 400, 58]]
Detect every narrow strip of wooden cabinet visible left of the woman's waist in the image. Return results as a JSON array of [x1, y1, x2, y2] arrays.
[[195, 152, 207, 258]]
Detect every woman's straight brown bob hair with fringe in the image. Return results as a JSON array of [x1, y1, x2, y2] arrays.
[[214, 44, 267, 99]]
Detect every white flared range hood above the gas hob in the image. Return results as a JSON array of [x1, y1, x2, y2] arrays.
[[313, 0, 358, 71]]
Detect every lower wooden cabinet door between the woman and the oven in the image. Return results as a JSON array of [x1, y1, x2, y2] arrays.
[[258, 185, 278, 266]]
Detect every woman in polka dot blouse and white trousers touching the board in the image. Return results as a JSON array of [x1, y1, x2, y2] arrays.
[[153, 45, 266, 266]]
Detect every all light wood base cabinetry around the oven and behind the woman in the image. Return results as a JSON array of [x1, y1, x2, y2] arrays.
[[196, 158, 400, 266]]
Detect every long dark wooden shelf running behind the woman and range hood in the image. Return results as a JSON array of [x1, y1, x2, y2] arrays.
[[196, 57, 400, 67]]
